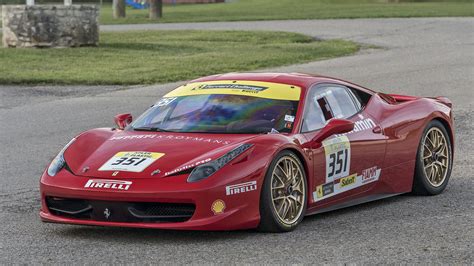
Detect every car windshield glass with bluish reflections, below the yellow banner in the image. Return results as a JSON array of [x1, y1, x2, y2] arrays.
[[131, 94, 298, 134]]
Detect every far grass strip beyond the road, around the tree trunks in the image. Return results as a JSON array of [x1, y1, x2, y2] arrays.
[[101, 0, 474, 24]]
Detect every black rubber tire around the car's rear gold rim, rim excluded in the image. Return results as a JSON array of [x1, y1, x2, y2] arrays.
[[412, 120, 453, 196]]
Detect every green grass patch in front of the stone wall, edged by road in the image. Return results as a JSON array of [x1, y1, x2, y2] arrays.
[[0, 31, 359, 85]]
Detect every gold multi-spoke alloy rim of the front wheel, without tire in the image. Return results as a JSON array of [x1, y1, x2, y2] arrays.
[[271, 156, 306, 225]]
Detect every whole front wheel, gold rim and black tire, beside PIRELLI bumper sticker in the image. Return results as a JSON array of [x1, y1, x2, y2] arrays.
[[258, 151, 308, 232]]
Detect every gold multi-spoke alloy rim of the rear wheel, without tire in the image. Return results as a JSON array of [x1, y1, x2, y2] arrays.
[[422, 127, 451, 187]]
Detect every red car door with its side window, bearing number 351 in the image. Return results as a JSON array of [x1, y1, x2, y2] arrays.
[[301, 84, 386, 207]]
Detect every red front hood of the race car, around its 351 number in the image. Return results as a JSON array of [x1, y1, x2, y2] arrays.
[[64, 128, 256, 178]]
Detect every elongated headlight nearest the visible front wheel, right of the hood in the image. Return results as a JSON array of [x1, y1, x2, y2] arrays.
[[188, 144, 252, 182]]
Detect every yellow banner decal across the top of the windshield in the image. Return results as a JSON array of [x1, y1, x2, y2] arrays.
[[164, 80, 301, 101]]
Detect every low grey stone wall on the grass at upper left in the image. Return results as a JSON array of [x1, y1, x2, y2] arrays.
[[2, 5, 99, 47]]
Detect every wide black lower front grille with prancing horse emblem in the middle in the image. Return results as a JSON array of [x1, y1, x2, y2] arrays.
[[46, 197, 196, 223]]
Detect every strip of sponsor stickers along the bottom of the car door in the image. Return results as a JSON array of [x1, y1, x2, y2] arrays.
[[313, 166, 381, 202]]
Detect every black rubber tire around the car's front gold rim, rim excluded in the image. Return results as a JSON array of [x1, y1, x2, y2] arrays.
[[257, 150, 308, 233]]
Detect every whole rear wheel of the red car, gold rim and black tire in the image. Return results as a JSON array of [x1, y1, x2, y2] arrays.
[[413, 120, 452, 195]]
